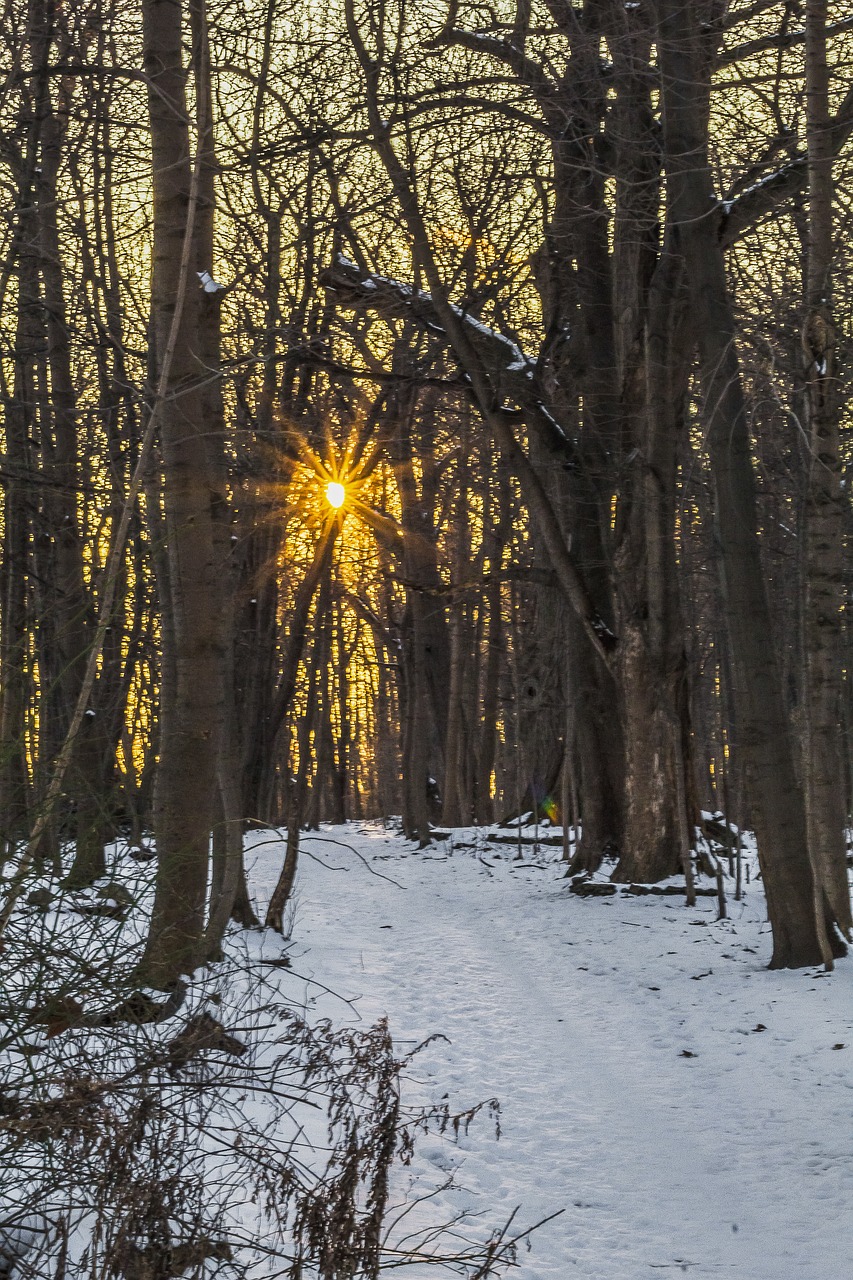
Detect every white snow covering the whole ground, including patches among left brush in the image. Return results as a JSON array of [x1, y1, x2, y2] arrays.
[[0, 823, 853, 1280]]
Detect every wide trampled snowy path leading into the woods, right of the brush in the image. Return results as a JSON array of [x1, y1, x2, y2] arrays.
[[245, 827, 853, 1280]]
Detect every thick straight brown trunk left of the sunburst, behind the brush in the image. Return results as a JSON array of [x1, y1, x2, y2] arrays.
[[141, 0, 224, 986]]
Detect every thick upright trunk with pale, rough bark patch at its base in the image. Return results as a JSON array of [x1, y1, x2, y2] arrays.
[[601, 10, 690, 881]]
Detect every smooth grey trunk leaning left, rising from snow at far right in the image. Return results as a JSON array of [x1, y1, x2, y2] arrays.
[[657, 0, 831, 969]]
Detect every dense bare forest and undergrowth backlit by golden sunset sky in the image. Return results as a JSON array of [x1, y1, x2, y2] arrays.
[[0, 0, 853, 1280]]
